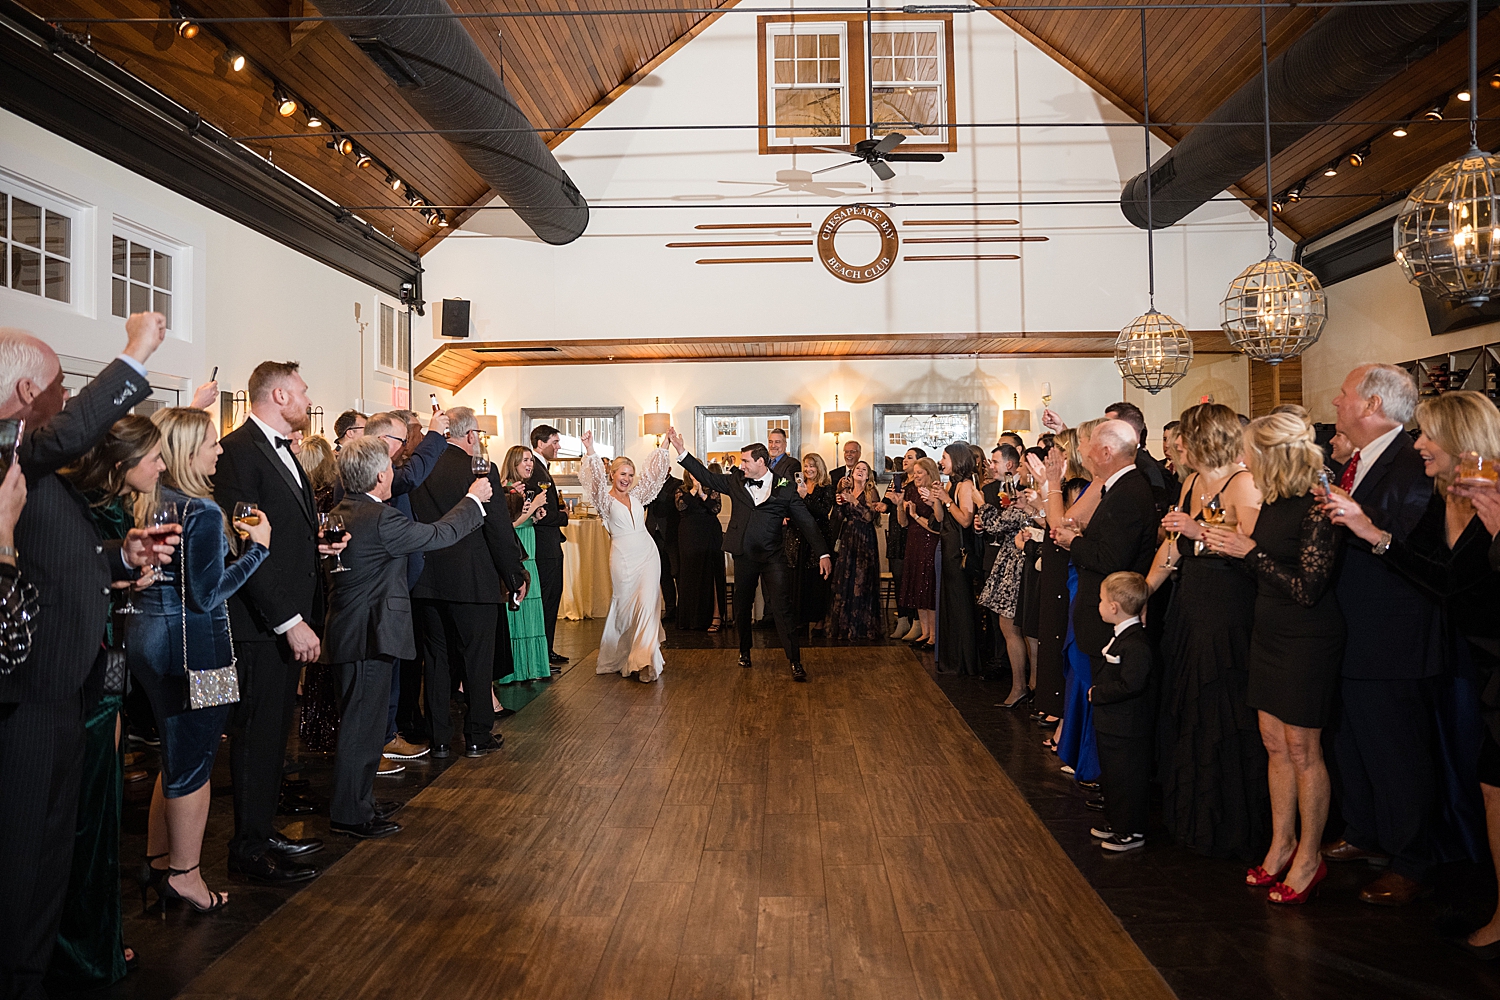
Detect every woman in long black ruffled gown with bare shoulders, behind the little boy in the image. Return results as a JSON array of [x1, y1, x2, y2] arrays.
[[1151, 403, 1271, 861]]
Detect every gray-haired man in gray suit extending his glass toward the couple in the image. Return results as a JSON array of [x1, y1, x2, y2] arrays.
[[323, 438, 491, 840]]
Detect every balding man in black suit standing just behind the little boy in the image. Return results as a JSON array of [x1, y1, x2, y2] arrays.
[[1047, 420, 1161, 673]]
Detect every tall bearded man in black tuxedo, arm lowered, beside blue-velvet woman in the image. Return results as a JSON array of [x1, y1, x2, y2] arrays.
[[213, 361, 337, 883]]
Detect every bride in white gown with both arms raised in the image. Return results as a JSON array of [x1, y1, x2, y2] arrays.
[[579, 430, 672, 682]]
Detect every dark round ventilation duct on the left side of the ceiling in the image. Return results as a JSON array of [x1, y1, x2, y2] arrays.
[[318, 0, 588, 244]]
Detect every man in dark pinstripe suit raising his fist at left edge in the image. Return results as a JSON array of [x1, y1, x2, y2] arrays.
[[0, 312, 176, 1000]]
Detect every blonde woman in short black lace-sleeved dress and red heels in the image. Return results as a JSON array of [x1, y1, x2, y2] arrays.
[[1203, 414, 1344, 903]]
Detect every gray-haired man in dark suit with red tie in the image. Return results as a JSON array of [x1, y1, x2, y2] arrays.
[[1323, 364, 1445, 906]]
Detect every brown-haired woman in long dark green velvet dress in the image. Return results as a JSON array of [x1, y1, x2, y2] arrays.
[[47, 417, 167, 991]]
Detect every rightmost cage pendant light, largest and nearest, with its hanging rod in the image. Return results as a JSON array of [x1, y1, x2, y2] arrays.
[[1395, 0, 1500, 306]]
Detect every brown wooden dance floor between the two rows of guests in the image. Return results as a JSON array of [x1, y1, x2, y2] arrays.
[[180, 646, 1172, 1000]]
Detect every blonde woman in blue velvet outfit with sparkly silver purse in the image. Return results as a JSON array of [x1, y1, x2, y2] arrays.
[[126, 408, 272, 912]]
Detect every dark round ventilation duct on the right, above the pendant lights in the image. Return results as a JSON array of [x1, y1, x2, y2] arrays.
[[1121, 3, 1464, 229]]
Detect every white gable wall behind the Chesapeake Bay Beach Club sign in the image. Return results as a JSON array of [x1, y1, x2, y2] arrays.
[[413, 0, 1284, 386]]
